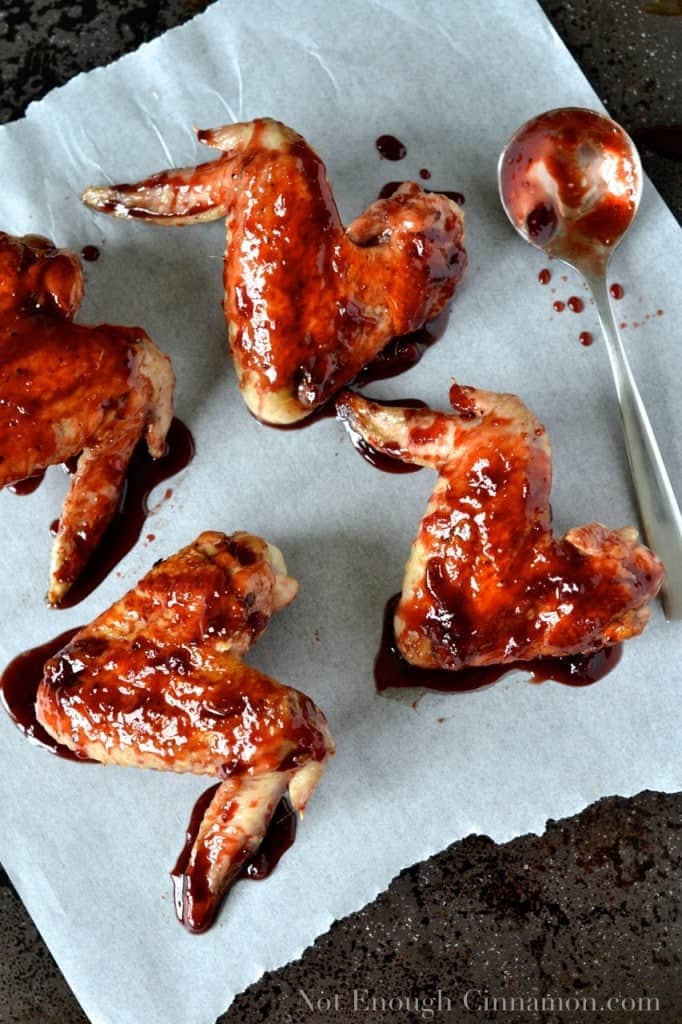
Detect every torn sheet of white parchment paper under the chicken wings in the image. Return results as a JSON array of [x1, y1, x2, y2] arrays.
[[0, 0, 682, 1024]]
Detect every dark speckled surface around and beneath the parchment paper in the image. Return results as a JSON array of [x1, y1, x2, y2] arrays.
[[0, 0, 682, 1024]]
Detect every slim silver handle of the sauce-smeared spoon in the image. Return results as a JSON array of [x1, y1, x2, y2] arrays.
[[586, 274, 682, 620]]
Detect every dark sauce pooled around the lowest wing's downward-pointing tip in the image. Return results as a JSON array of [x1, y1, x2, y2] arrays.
[[171, 782, 297, 932]]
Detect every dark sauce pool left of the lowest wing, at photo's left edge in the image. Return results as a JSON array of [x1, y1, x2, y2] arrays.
[[0, 626, 93, 763]]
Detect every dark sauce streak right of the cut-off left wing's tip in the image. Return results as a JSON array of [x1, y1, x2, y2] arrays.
[[57, 419, 195, 608]]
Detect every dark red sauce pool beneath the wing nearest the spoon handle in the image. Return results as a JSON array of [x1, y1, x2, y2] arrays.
[[374, 594, 622, 693]]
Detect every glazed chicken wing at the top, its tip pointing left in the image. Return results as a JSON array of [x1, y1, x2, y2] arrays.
[[83, 119, 466, 424]]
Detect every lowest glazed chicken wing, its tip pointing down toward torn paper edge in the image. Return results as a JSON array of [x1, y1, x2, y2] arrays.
[[36, 532, 334, 931]]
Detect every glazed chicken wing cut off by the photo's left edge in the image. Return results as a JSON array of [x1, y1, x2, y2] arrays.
[[0, 232, 174, 603]]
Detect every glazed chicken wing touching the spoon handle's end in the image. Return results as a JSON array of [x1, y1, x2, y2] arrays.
[[337, 384, 663, 670]]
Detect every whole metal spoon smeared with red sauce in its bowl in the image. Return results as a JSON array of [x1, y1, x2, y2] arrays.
[[498, 106, 682, 620]]
